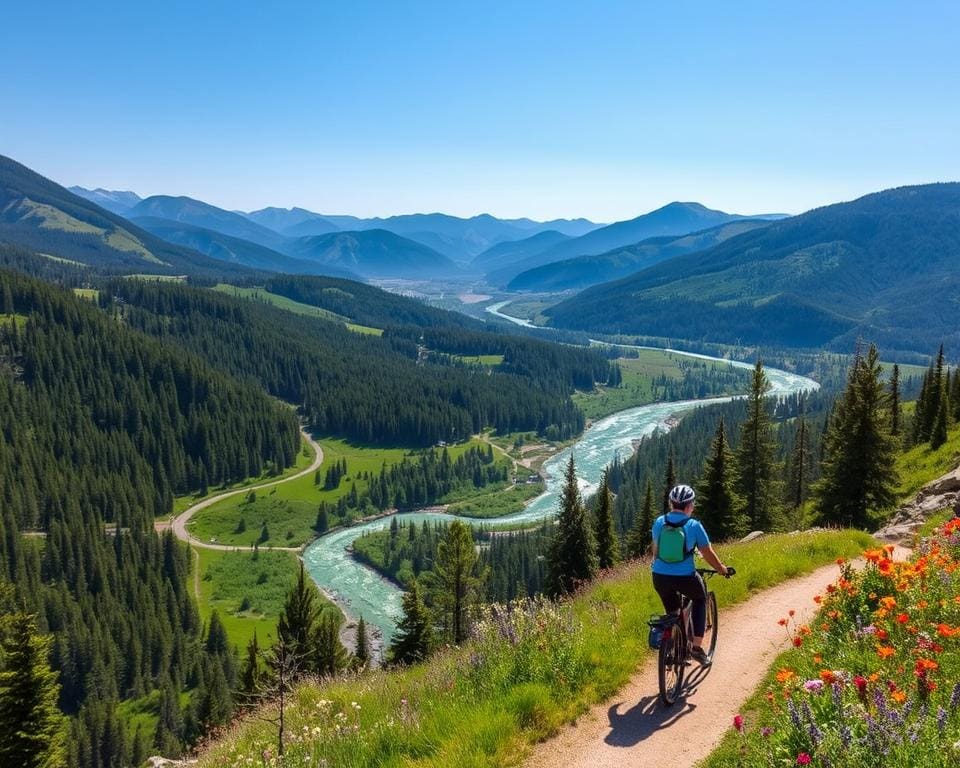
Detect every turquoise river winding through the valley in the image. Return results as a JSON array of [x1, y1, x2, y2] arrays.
[[303, 304, 819, 638]]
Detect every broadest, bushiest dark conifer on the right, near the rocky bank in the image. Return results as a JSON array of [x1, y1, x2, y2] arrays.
[[814, 345, 897, 528]]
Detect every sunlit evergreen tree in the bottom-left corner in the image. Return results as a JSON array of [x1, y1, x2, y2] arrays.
[[0, 611, 66, 768]]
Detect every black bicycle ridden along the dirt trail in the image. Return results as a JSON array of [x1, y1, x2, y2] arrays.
[[647, 568, 736, 707]]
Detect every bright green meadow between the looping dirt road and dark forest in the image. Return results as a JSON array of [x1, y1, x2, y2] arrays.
[[188, 438, 496, 547]]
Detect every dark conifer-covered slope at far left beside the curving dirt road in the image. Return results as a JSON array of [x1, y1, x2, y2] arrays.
[[0, 270, 299, 768]]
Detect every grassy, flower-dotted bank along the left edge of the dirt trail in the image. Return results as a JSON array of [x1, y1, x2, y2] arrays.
[[199, 531, 872, 768]]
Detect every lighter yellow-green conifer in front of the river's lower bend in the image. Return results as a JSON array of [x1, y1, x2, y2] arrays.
[[427, 520, 484, 645]]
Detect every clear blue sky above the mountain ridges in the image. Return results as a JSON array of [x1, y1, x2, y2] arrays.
[[0, 0, 960, 221]]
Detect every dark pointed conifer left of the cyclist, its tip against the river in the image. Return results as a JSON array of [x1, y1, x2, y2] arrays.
[[547, 454, 597, 597]]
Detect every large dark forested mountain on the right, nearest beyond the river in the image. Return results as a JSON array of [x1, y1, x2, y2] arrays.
[[545, 183, 960, 352]]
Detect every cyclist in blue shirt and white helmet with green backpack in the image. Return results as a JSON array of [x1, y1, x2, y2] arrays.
[[653, 485, 727, 666]]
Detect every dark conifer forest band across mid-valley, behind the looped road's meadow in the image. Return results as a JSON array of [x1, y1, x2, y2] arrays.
[[100, 280, 609, 445]]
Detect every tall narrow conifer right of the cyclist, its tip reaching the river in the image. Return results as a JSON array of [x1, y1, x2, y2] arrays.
[[734, 360, 780, 532]]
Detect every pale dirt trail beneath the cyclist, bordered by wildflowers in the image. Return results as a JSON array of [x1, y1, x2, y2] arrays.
[[526, 550, 906, 768]]
